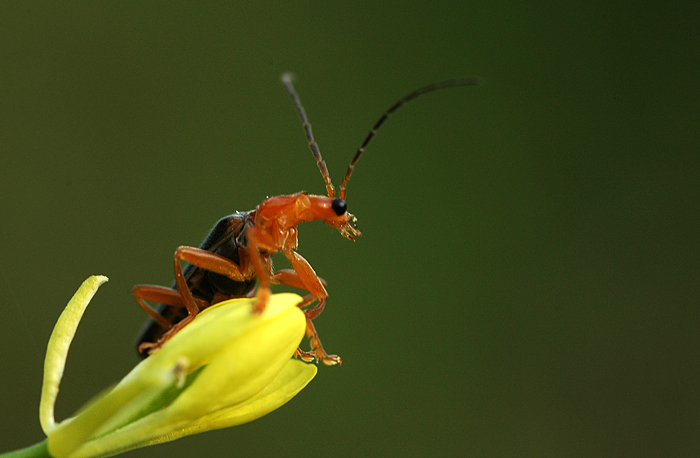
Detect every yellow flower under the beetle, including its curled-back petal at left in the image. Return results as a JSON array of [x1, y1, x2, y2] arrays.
[[21, 277, 316, 458]]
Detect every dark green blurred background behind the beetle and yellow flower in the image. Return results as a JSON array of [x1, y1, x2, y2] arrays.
[[0, 0, 700, 458]]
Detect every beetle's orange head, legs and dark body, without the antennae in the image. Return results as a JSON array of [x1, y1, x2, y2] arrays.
[[134, 192, 360, 365]]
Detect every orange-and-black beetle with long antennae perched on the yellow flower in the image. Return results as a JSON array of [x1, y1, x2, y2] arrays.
[[132, 73, 479, 365]]
